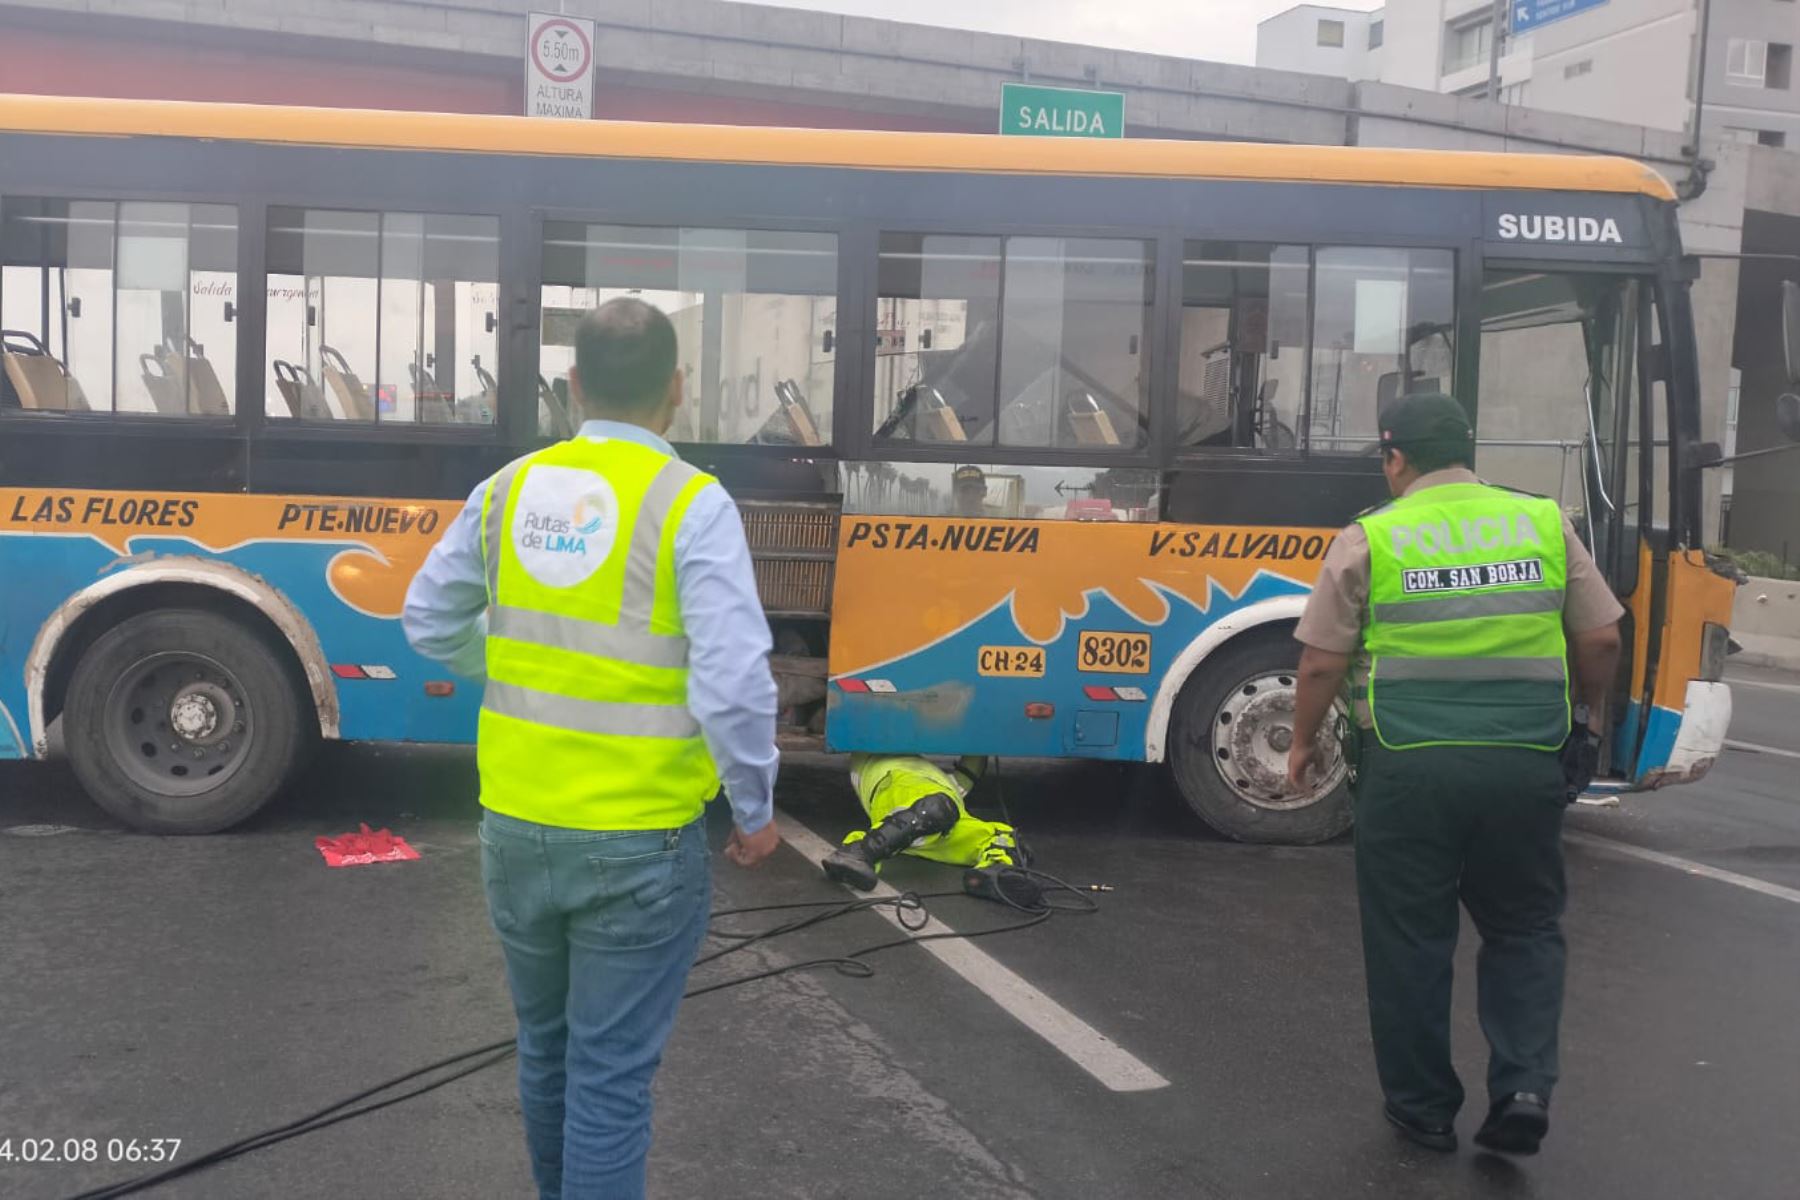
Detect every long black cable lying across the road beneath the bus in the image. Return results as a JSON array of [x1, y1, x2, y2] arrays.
[[59, 874, 1100, 1200]]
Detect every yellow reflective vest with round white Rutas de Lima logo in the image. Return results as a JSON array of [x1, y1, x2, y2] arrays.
[[477, 437, 718, 829]]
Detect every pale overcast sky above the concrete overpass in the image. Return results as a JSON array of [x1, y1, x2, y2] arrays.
[[763, 0, 1381, 63]]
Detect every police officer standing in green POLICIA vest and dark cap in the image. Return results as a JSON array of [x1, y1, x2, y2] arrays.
[[1289, 396, 1624, 1153]]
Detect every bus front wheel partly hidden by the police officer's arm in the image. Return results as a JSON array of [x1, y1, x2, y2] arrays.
[[1168, 635, 1350, 846]]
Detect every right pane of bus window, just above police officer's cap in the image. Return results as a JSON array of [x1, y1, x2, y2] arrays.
[[1307, 246, 1456, 455]]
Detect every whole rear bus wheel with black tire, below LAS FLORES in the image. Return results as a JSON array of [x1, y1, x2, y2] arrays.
[[63, 608, 311, 833]]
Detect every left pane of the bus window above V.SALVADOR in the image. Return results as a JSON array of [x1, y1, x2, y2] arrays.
[[1175, 241, 1310, 452]]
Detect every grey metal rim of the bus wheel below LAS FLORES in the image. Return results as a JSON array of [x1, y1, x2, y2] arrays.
[[103, 651, 256, 795]]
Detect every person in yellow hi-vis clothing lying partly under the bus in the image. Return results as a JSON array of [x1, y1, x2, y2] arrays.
[[821, 754, 1026, 894]]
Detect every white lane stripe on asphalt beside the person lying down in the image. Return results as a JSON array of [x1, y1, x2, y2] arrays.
[[776, 813, 1168, 1092]]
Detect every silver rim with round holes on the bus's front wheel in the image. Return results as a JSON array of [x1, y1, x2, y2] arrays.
[[1211, 671, 1345, 811]]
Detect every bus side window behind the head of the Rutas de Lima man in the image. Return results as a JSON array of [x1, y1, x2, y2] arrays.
[[538, 221, 837, 446]]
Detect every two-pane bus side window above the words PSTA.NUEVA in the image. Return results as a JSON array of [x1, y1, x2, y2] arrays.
[[873, 234, 1156, 452]]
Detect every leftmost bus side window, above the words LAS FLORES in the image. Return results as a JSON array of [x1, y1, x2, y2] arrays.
[[0, 198, 238, 417]]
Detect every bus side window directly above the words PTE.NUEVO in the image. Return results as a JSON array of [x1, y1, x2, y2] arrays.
[[266, 207, 500, 425]]
